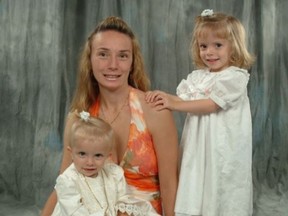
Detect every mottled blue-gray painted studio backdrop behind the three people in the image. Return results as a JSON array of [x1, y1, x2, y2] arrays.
[[0, 0, 288, 216]]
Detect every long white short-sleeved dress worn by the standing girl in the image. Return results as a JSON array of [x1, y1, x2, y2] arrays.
[[175, 67, 252, 216]]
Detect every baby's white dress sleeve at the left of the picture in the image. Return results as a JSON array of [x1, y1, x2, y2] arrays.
[[52, 175, 104, 216]]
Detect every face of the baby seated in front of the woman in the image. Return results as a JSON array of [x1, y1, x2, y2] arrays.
[[68, 136, 111, 177]]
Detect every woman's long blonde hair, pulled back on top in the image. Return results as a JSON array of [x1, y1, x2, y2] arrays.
[[70, 16, 150, 111]]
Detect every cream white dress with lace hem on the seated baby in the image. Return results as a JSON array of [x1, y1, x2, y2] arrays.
[[52, 163, 158, 216]]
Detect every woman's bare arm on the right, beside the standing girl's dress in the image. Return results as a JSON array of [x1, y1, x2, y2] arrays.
[[145, 101, 178, 216]]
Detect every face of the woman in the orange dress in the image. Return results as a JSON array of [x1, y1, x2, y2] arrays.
[[91, 30, 133, 89]]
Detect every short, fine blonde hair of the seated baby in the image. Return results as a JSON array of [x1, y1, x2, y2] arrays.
[[69, 113, 115, 151]]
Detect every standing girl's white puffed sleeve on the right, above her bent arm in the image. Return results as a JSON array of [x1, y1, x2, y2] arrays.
[[210, 67, 249, 110]]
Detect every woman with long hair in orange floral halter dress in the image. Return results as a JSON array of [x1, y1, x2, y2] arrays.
[[42, 17, 178, 216]]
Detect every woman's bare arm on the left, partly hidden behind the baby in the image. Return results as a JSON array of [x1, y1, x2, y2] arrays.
[[41, 113, 75, 216]]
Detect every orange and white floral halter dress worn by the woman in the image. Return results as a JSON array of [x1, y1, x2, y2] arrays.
[[89, 88, 162, 215]]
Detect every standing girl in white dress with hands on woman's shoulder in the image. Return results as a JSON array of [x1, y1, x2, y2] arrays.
[[146, 10, 254, 216]]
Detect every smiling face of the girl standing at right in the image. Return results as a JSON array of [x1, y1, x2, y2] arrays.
[[198, 30, 231, 72]]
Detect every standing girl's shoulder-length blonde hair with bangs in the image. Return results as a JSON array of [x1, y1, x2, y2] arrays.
[[191, 13, 255, 69]]
